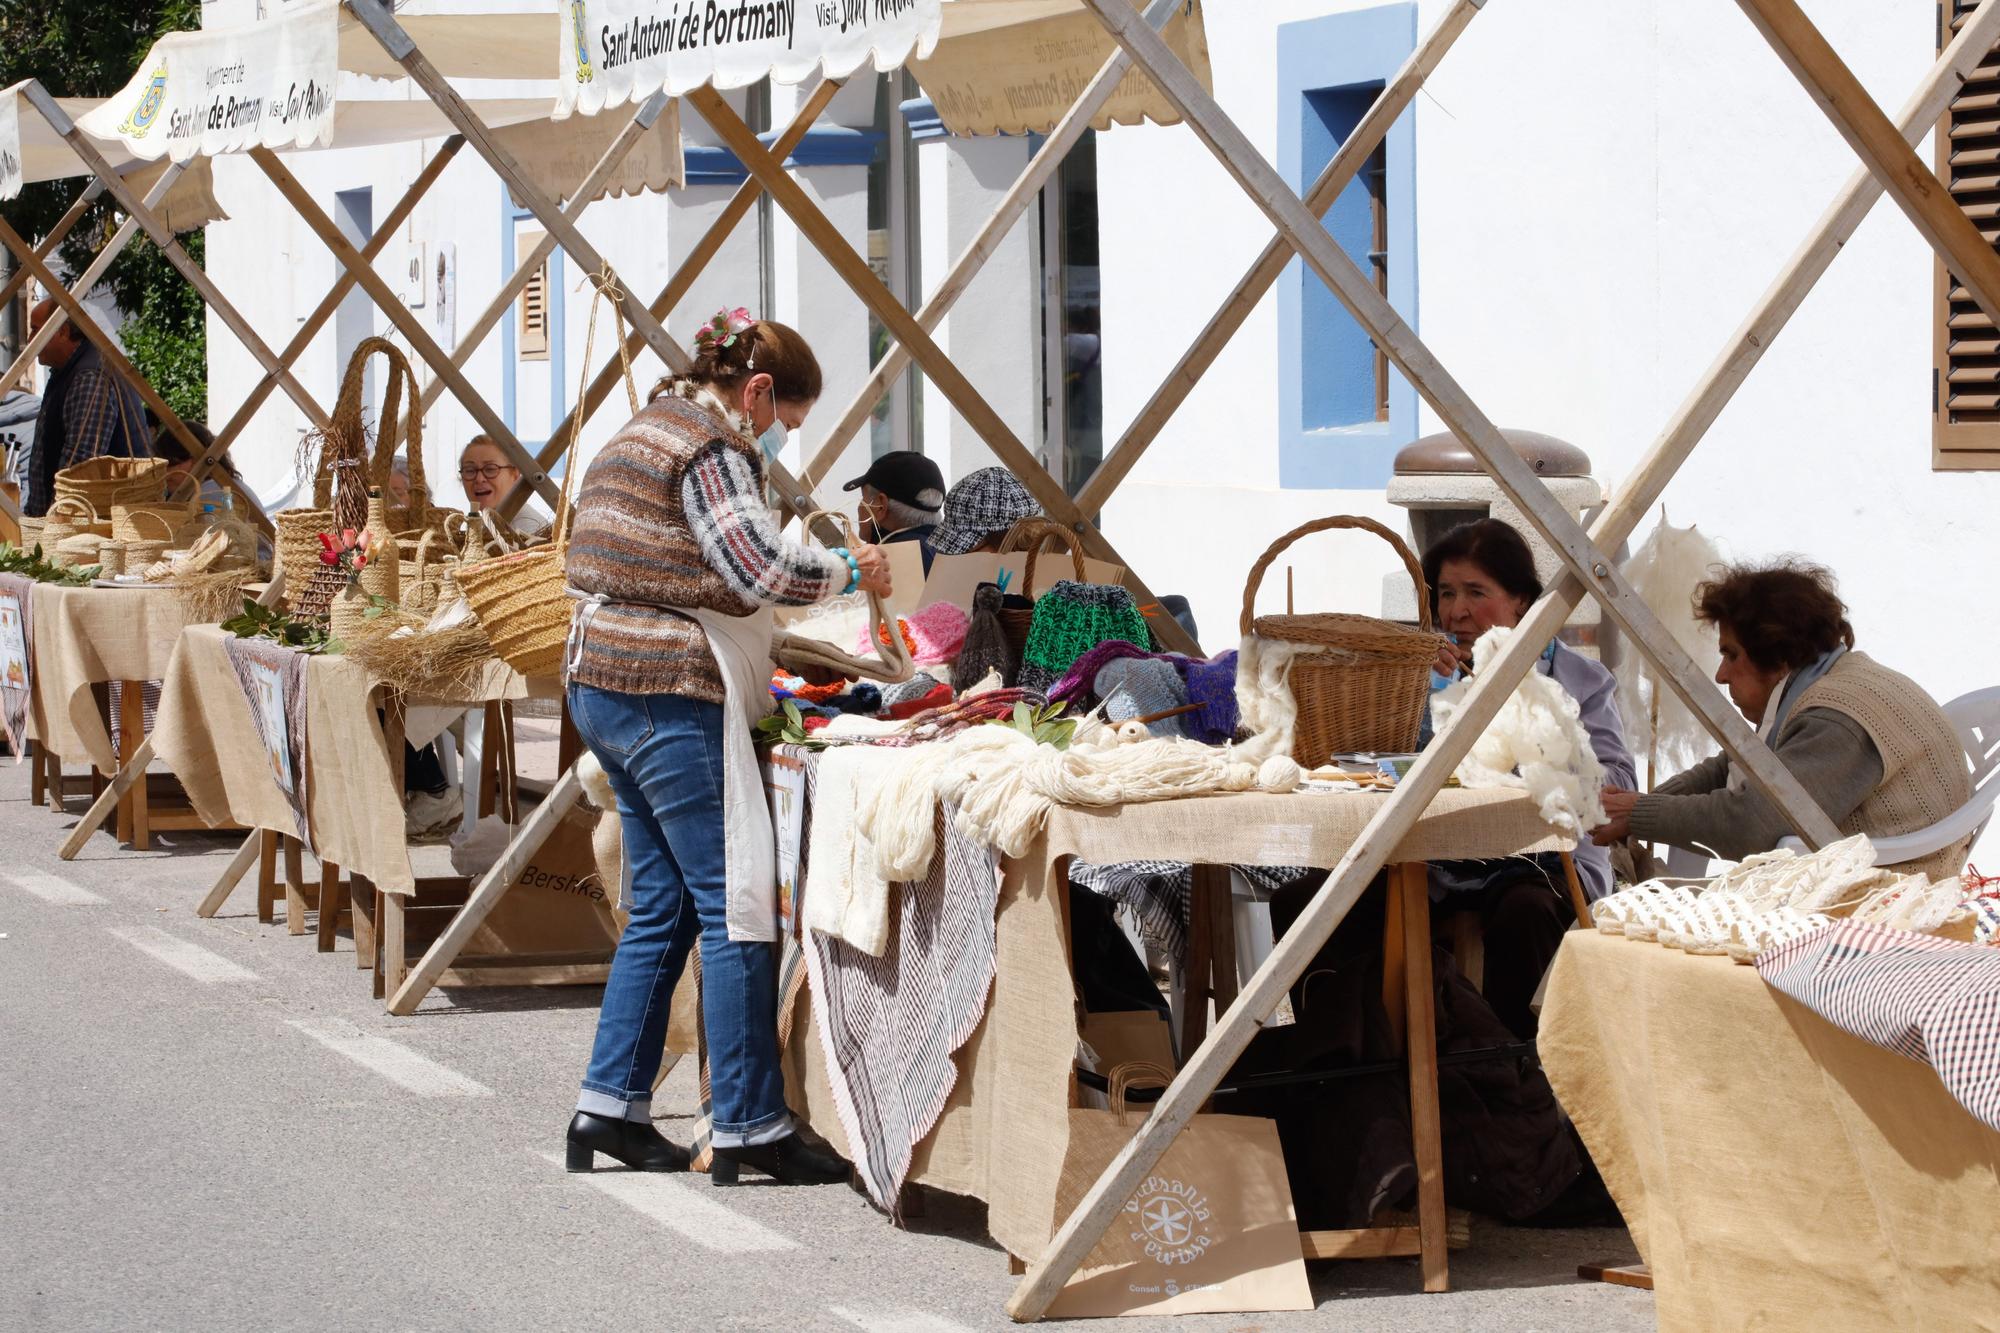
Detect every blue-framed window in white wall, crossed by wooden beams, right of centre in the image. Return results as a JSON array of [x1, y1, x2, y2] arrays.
[[1278, 4, 1418, 490]]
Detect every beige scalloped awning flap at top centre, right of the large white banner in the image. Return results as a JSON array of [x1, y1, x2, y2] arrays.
[[910, 0, 1212, 134]]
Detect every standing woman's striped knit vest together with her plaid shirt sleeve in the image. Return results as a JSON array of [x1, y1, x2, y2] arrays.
[[566, 394, 848, 703]]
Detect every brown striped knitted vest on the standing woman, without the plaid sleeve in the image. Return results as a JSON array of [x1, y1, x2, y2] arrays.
[[564, 394, 762, 703]]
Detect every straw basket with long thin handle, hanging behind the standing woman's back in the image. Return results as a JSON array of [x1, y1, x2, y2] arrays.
[[456, 270, 638, 677]]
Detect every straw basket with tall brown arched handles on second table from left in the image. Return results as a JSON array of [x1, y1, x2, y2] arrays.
[[274, 338, 428, 616]]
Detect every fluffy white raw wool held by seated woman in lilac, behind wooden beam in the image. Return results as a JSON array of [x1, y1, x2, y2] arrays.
[[1430, 626, 1608, 837]]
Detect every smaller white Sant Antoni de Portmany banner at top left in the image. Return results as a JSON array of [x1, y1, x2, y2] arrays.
[[78, 4, 340, 162]]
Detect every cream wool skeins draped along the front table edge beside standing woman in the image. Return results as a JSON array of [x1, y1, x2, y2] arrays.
[[860, 727, 1298, 881]]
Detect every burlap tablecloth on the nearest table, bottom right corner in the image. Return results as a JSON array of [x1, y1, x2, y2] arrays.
[[1540, 931, 2000, 1329]]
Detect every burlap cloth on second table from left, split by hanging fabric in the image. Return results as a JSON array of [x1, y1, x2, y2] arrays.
[[152, 624, 536, 895]]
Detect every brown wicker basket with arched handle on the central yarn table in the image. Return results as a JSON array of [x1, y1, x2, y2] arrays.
[[1240, 514, 1444, 769]]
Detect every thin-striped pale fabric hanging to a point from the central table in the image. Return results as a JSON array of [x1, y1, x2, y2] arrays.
[[798, 759, 992, 1215]]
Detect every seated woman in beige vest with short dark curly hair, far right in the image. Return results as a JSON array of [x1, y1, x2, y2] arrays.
[[1594, 560, 1972, 877]]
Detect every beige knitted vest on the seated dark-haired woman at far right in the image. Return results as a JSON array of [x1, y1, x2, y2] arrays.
[[1798, 652, 1972, 879]]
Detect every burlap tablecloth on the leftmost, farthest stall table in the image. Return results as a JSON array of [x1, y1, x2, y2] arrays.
[[32, 582, 188, 773]]
